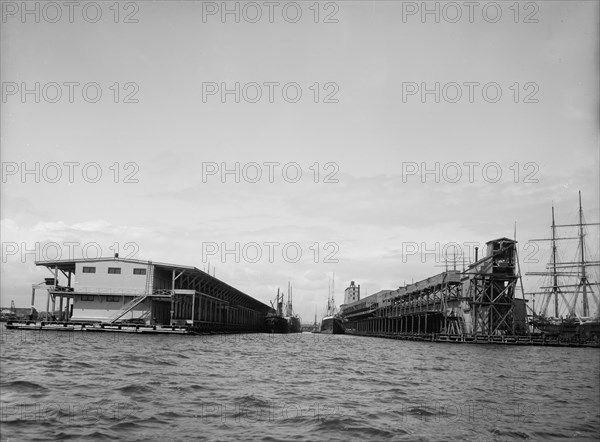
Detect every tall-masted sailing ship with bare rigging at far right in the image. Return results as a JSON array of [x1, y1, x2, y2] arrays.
[[526, 191, 600, 339]]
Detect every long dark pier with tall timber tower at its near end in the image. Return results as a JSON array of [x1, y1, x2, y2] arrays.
[[341, 238, 600, 347]]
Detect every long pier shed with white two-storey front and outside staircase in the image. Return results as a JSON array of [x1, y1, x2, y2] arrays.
[[18, 254, 272, 334]]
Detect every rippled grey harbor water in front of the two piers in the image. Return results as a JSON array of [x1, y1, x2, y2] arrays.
[[0, 328, 600, 441]]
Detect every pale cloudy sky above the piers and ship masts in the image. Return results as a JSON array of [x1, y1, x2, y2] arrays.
[[0, 1, 600, 322]]
